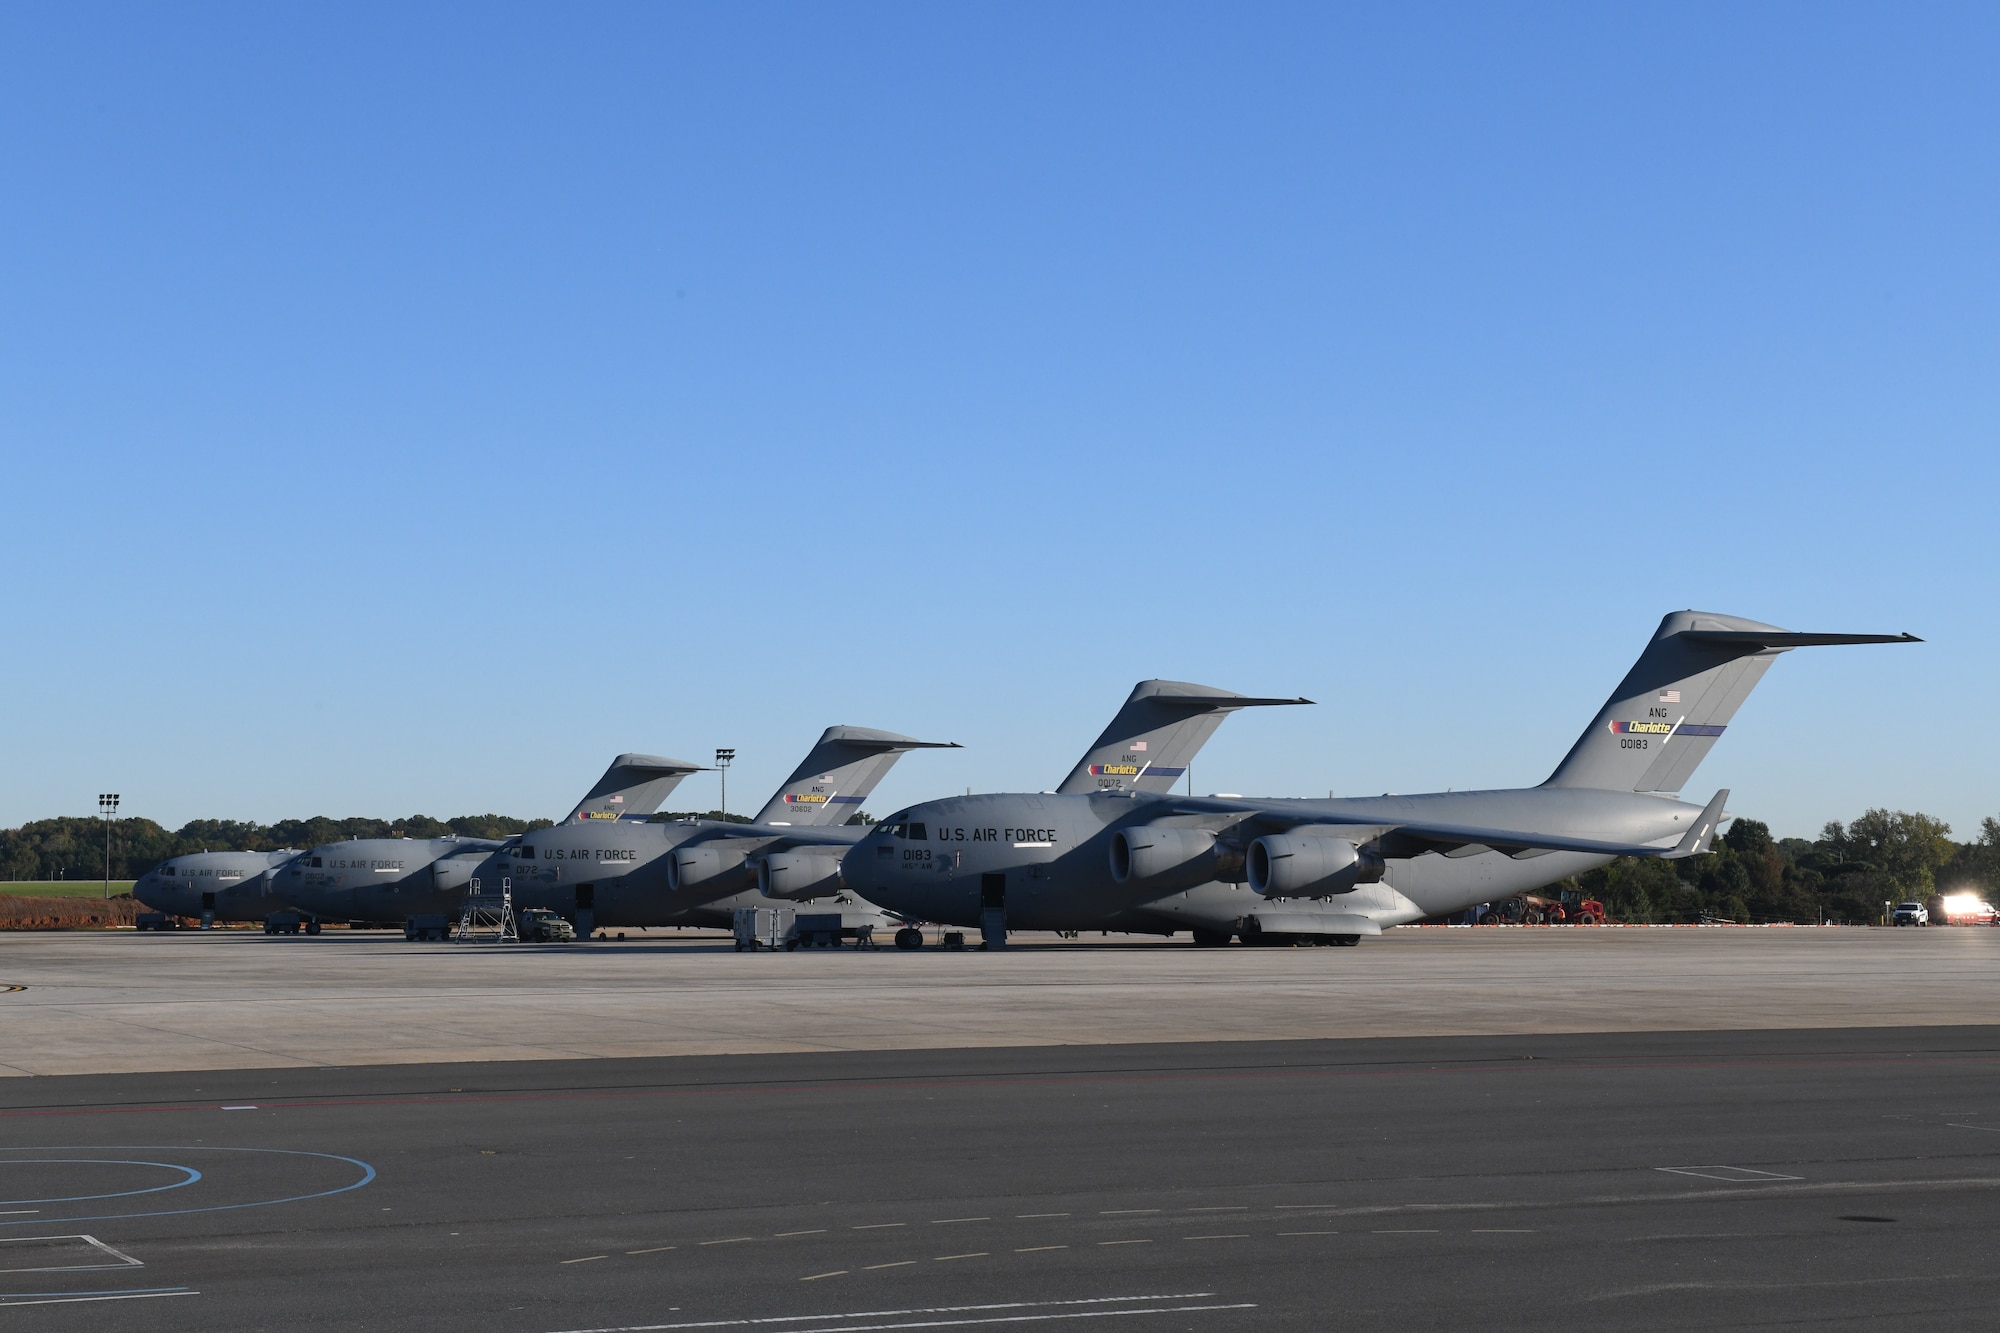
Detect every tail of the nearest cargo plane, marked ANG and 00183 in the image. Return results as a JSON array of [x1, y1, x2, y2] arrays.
[[1542, 610, 1922, 793]]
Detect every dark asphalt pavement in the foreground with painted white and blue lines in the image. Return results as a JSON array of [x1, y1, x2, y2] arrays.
[[0, 1020, 2000, 1333]]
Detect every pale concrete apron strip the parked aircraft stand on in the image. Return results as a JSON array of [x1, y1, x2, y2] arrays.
[[0, 929, 2000, 1077]]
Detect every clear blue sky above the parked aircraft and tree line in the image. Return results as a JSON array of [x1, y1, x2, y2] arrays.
[[0, 2, 2000, 835]]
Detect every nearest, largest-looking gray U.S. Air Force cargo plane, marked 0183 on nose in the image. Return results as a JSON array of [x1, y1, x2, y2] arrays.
[[842, 610, 1920, 947]]
